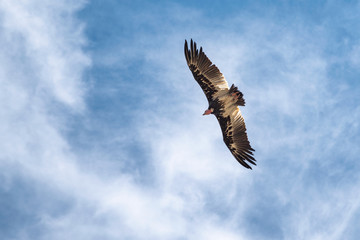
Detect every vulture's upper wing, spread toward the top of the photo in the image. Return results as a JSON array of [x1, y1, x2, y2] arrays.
[[184, 39, 229, 102]]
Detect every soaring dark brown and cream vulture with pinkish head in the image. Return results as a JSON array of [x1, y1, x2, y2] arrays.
[[184, 39, 256, 169]]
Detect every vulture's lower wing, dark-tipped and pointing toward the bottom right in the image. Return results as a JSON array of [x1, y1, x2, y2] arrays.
[[215, 101, 256, 169]]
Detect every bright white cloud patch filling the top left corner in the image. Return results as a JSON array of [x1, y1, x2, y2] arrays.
[[0, 1, 90, 107]]
